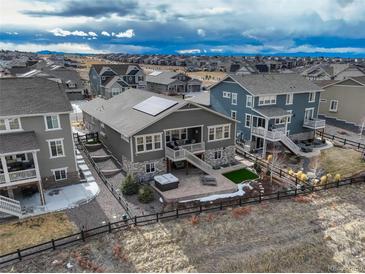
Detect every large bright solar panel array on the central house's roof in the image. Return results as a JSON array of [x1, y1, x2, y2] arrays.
[[133, 96, 177, 116]]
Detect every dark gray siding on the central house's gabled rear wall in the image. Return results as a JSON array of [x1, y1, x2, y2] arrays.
[[133, 109, 235, 162]]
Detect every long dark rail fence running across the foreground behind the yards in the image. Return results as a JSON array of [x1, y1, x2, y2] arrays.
[[0, 175, 365, 265]]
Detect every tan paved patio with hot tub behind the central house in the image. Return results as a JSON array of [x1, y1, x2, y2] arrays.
[[151, 168, 237, 203]]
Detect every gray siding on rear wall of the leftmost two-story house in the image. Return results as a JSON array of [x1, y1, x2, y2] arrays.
[[20, 114, 78, 187]]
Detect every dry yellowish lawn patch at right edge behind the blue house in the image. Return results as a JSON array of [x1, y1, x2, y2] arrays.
[[311, 147, 365, 177]]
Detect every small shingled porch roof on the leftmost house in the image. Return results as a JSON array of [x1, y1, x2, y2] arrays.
[[0, 131, 39, 154]]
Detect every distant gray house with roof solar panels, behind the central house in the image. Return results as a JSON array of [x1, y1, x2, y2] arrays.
[[146, 71, 202, 95]]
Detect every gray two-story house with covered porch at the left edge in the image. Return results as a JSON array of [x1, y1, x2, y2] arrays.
[[0, 78, 80, 204]]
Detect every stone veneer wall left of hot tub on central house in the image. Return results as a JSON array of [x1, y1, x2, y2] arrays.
[[122, 156, 167, 177]]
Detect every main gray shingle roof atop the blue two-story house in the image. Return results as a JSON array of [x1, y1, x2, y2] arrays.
[[229, 73, 322, 95]]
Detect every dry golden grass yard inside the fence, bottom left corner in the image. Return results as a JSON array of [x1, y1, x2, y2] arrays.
[[0, 213, 77, 255]]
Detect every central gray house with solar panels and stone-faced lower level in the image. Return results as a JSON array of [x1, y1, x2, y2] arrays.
[[81, 89, 236, 178]]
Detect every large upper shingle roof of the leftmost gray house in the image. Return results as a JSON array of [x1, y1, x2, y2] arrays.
[[0, 77, 72, 116]]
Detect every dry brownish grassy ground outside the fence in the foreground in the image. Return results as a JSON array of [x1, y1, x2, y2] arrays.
[[3, 185, 365, 272]]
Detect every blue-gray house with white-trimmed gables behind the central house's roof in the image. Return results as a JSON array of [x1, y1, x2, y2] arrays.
[[89, 64, 146, 99]]
